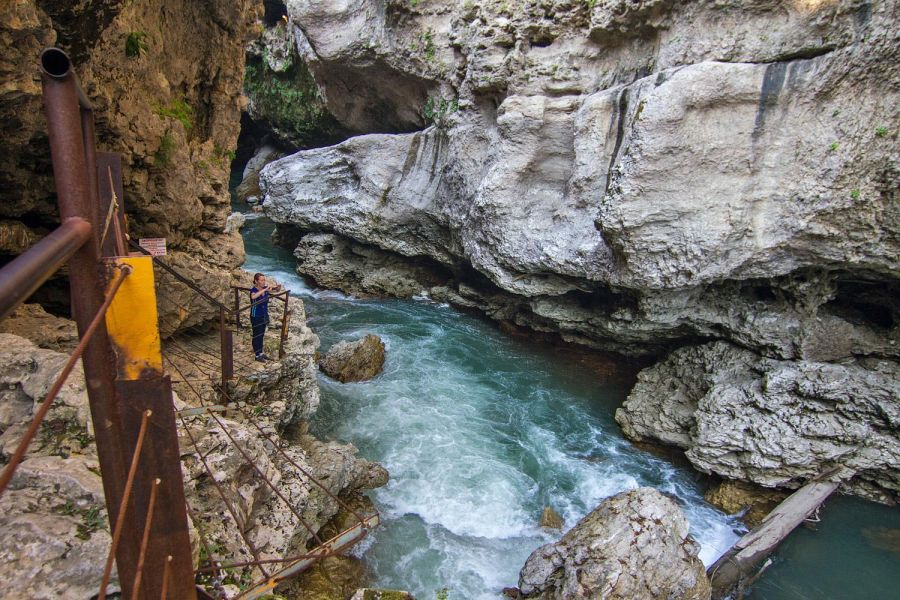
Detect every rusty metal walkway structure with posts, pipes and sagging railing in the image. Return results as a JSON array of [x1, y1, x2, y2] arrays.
[[0, 48, 379, 600]]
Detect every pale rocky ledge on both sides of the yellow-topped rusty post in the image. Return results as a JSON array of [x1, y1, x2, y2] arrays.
[[0, 299, 388, 600]]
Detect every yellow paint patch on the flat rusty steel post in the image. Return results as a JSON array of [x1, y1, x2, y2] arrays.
[[106, 256, 162, 380]]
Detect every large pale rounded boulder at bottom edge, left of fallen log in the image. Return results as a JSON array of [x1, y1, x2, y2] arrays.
[[519, 488, 710, 600]]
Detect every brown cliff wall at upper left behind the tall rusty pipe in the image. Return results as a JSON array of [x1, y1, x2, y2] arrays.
[[0, 0, 261, 334]]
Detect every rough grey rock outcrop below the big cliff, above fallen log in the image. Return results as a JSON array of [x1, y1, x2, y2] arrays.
[[616, 342, 900, 501]]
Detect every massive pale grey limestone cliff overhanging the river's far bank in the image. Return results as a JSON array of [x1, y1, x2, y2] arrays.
[[255, 0, 900, 495]]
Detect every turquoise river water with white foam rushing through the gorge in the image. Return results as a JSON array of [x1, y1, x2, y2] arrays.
[[237, 209, 900, 600]]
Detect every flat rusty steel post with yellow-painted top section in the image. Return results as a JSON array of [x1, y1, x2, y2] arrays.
[[106, 256, 197, 600]]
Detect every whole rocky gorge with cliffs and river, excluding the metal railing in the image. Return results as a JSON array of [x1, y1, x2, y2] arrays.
[[0, 0, 900, 600]]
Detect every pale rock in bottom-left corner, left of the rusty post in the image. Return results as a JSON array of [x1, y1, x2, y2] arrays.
[[0, 333, 118, 600]]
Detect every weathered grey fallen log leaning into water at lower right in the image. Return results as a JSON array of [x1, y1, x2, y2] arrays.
[[706, 467, 853, 598]]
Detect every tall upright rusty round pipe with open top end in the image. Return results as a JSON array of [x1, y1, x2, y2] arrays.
[[40, 48, 140, 596]]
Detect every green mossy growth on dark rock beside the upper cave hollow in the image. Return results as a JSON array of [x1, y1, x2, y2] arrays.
[[244, 59, 338, 146]]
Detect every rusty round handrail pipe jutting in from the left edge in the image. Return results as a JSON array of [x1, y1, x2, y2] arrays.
[[0, 217, 91, 320]]
